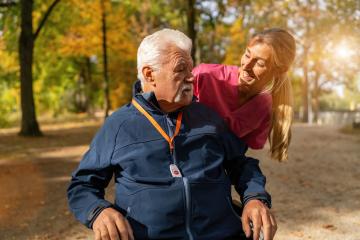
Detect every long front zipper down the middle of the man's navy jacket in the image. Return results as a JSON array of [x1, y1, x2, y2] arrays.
[[166, 115, 194, 240]]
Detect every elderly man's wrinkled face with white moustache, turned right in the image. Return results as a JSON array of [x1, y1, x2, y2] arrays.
[[153, 45, 194, 110]]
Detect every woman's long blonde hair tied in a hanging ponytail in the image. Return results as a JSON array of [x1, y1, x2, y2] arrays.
[[249, 28, 296, 162]]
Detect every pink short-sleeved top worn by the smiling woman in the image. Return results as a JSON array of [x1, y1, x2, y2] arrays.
[[193, 64, 272, 149]]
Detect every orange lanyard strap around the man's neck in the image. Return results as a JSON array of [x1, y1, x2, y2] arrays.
[[132, 99, 182, 152]]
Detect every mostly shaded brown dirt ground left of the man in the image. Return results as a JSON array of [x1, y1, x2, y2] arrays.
[[0, 123, 114, 239]]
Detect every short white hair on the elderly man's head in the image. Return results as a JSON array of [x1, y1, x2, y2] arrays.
[[137, 28, 192, 86]]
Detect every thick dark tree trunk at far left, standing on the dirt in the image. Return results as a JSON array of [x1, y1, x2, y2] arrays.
[[19, 0, 42, 136]]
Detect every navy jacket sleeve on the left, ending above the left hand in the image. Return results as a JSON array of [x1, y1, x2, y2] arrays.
[[67, 117, 118, 228]]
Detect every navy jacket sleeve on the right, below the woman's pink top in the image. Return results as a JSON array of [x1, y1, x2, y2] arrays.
[[223, 128, 271, 207]]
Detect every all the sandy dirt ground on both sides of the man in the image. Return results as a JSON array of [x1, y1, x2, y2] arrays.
[[0, 121, 360, 240]]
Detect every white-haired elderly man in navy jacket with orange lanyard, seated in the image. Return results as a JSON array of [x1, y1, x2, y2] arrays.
[[68, 29, 276, 240]]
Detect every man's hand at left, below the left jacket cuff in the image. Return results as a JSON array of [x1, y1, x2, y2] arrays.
[[93, 208, 134, 240]]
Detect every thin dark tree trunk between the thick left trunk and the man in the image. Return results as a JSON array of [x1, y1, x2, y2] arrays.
[[100, 0, 110, 118]]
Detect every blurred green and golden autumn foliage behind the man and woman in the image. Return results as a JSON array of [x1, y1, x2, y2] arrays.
[[0, 0, 360, 126]]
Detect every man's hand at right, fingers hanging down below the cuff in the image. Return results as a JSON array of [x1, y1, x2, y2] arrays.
[[241, 200, 277, 240]]
